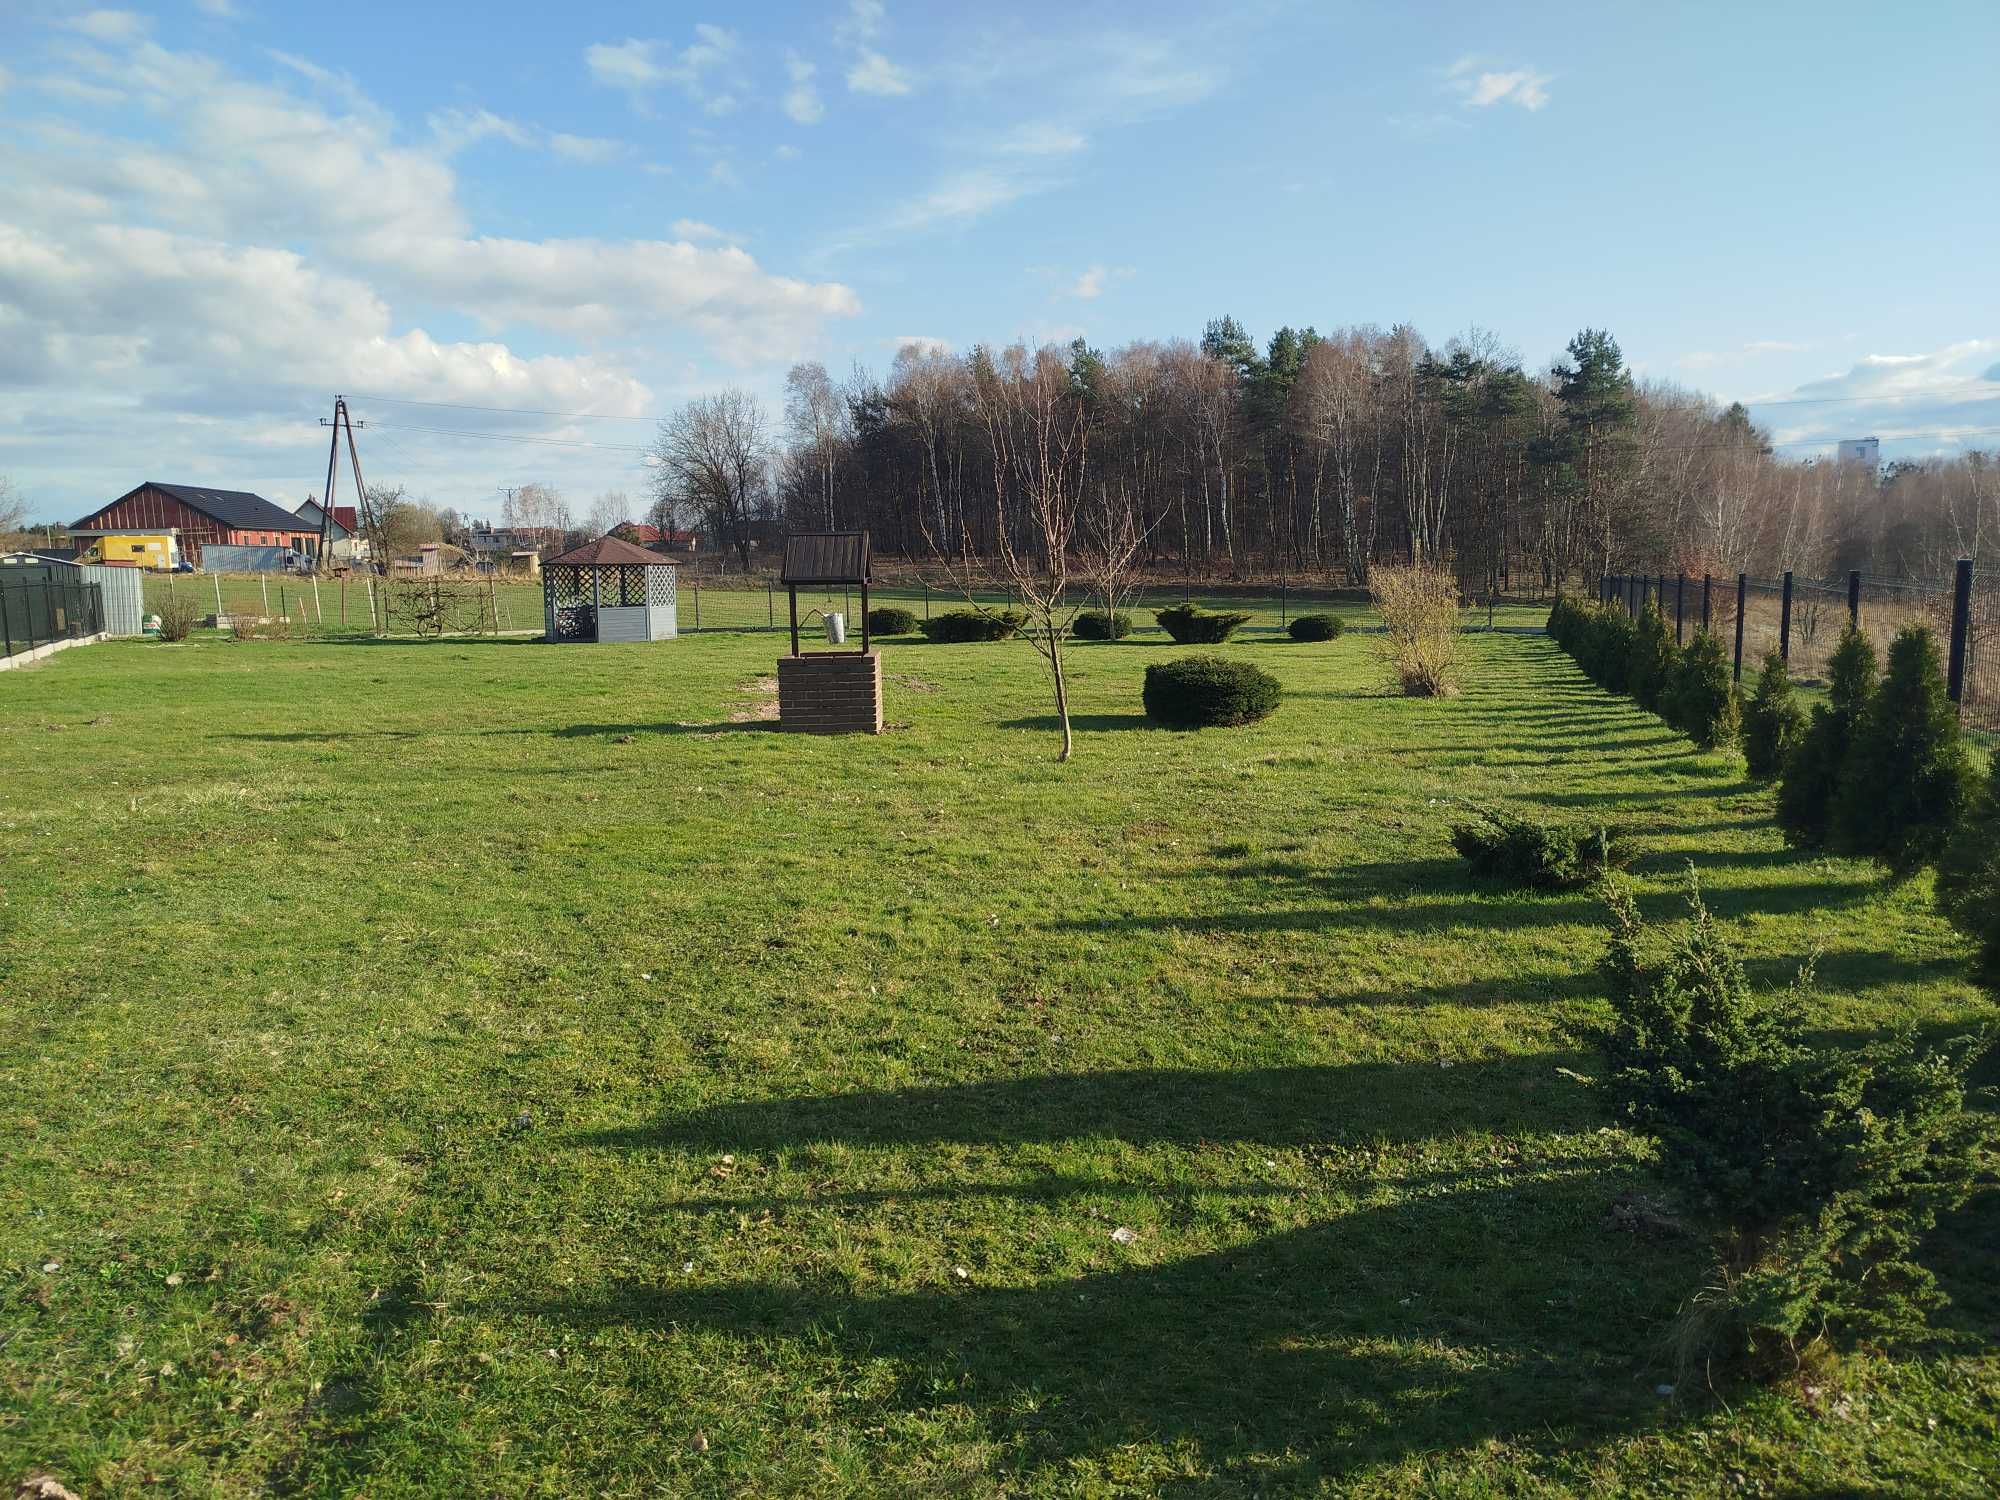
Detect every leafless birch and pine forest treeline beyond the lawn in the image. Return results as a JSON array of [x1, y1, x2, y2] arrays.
[[652, 318, 2000, 592]]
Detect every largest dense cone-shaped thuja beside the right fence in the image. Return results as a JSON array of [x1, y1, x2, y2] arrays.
[[1832, 624, 1976, 874]]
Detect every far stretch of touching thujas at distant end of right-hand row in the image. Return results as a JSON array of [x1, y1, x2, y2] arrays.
[[1548, 596, 1742, 750]]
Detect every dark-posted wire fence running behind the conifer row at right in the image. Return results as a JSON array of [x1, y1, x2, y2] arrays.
[[1598, 558, 2000, 732]]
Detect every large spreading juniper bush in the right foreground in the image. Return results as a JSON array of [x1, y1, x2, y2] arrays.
[[1598, 870, 1996, 1374]]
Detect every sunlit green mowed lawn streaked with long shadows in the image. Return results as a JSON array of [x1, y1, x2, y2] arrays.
[[0, 620, 2000, 1496]]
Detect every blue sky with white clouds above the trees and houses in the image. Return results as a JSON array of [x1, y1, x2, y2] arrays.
[[0, 0, 2000, 520]]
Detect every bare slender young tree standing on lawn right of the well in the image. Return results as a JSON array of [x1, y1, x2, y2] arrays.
[[926, 344, 1090, 760]]
